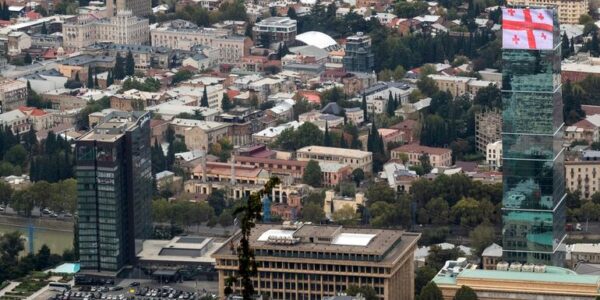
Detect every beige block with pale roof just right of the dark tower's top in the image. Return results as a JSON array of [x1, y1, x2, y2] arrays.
[[170, 118, 229, 150]]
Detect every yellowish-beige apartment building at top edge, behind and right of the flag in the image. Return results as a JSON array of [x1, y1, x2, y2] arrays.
[[507, 0, 590, 24]]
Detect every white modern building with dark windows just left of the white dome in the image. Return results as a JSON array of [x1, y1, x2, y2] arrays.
[[252, 17, 297, 48]]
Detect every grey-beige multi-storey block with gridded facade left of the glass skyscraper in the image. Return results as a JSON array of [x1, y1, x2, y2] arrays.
[[475, 109, 502, 153]]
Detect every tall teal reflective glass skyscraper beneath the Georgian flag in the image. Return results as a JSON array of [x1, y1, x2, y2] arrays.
[[502, 11, 565, 266]]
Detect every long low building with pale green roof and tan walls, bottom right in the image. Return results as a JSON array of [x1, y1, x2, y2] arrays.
[[432, 257, 600, 300]]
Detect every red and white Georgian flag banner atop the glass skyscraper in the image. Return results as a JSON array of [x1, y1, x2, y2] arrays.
[[502, 7, 554, 50]]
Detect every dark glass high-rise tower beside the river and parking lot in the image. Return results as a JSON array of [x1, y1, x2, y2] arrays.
[[76, 111, 152, 276]]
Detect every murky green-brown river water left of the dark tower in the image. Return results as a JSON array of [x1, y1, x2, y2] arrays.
[[0, 224, 73, 254]]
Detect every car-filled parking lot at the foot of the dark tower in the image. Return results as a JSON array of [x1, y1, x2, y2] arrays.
[[47, 280, 216, 300]]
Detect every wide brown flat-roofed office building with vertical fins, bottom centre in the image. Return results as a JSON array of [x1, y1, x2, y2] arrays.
[[213, 223, 419, 300]]
